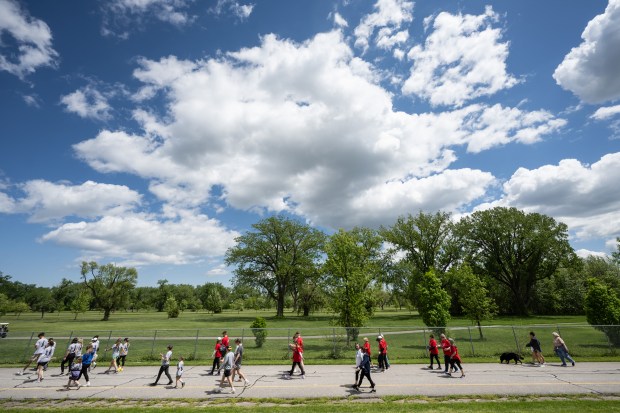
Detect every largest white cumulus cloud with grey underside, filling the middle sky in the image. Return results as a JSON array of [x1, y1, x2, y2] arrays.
[[74, 30, 564, 227]]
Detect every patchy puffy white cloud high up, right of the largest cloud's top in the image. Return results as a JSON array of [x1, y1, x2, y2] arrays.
[[402, 7, 518, 106]]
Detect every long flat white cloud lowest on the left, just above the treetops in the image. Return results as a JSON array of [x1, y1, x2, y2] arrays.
[[41, 211, 239, 265]]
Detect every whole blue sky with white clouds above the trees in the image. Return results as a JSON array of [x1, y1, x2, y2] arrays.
[[0, 0, 620, 286]]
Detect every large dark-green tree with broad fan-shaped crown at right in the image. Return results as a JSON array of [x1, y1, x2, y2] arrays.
[[458, 207, 574, 315]]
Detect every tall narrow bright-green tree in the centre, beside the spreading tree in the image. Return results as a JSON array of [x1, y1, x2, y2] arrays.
[[323, 228, 382, 344]]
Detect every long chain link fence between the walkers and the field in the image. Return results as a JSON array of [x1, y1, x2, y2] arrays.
[[0, 324, 620, 364]]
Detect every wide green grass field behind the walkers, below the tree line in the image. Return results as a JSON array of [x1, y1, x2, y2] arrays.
[[0, 309, 620, 365]]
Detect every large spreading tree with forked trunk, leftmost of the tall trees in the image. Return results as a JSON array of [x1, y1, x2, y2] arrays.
[[226, 216, 325, 317]]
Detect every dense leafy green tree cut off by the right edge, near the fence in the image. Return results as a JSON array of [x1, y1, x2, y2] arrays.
[[585, 278, 620, 346]]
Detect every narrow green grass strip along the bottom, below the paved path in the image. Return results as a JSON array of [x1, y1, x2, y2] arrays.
[[0, 393, 620, 413]]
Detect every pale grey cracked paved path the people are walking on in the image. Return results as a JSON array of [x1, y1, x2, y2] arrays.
[[0, 362, 620, 399]]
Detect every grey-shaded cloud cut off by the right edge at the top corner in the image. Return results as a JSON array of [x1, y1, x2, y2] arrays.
[[553, 0, 620, 103]]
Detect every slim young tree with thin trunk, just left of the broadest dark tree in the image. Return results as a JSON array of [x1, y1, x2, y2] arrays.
[[449, 264, 497, 340]]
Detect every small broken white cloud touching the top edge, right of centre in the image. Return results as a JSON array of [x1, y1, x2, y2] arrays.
[[354, 0, 413, 52]]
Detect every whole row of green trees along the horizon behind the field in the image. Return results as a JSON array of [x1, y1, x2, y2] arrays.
[[0, 207, 620, 342]]
